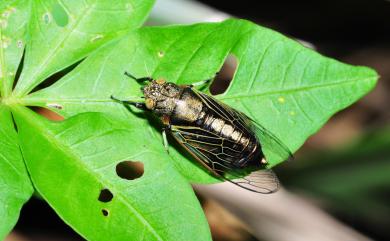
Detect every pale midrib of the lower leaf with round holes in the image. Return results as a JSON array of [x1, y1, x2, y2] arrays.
[[14, 107, 163, 241]]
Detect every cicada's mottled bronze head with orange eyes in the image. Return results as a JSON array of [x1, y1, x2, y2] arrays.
[[143, 80, 180, 115]]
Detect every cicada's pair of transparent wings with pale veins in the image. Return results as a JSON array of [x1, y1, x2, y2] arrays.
[[171, 91, 291, 193]]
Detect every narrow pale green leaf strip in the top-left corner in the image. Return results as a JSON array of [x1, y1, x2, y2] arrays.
[[0, 0, 29, 96]]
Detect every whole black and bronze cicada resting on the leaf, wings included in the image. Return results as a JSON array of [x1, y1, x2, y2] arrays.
[[111, 72, 291, 193]]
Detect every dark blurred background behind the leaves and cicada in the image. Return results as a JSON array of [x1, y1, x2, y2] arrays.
[[6, 0, 390, 241]]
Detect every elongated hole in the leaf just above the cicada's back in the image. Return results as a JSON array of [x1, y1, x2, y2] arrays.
[[210, 54, 237, 95]]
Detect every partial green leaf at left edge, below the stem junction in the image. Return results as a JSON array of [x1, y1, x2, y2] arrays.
[[0, 105, 33, 240]]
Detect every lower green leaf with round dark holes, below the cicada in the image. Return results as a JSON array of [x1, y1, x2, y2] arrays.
[[13, 106, 211, 241]]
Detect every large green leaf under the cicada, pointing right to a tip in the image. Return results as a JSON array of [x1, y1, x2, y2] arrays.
[[24, 20, 377, 182]]
